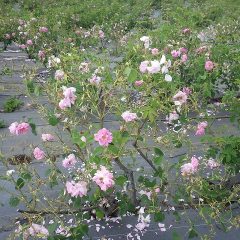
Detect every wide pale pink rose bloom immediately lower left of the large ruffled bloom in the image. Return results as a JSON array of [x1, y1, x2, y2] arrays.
[[66, 181, 88, 197]]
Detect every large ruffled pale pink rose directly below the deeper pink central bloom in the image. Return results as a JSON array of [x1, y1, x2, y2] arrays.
[[92, 166, 115, 191]]
